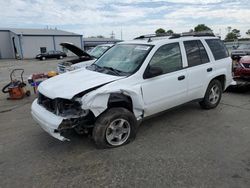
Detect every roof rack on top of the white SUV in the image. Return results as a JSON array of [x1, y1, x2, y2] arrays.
[[134, 31, 215, 42]]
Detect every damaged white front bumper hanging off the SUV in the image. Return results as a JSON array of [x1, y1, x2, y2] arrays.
[[31, 99, 69, 141]]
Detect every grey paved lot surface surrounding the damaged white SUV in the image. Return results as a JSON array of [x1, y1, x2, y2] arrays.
[[0, 60, 250, 188]]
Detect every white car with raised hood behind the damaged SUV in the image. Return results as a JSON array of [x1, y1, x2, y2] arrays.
[[57, 42, 114, 74]]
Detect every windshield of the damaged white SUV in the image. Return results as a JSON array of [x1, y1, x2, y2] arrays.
[[91, 44, 152, 76]]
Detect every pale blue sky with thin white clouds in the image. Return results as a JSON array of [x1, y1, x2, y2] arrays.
[[0, 0, 250, 40]]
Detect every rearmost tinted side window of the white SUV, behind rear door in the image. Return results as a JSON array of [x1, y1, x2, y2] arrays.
[[206, 39, 228, 60]]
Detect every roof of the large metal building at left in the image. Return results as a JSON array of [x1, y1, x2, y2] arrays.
[[0, 28, 82, 36]]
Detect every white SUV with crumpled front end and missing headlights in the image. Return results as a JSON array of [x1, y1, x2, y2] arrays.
[[31, 34, 232, 148]]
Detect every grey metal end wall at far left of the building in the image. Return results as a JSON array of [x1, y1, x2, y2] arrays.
[[0, 31, 15, 59]]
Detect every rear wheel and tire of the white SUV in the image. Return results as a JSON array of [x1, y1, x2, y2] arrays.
[[200, 79, 222, 109]]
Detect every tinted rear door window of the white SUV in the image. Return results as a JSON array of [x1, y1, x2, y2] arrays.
[[184, 40, 209, 67]]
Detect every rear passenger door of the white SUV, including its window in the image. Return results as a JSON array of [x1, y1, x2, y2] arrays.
[[183, 40, 214, 101]]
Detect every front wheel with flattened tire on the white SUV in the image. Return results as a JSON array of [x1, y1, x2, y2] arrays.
[[92, 108, 138, 149]]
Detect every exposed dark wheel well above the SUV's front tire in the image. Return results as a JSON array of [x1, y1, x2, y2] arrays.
[[108, 93, 133, 112]]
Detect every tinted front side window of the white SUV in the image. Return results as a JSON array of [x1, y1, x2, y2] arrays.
[[150, 43, 182, 73]]
